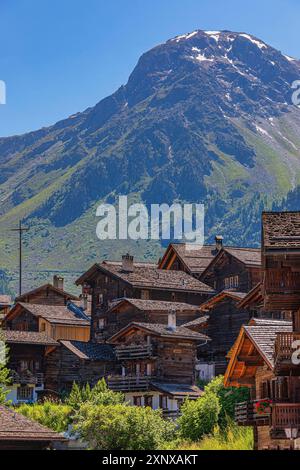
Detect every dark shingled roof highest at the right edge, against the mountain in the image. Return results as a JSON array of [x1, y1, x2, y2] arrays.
[[262, 211, 300, 250]]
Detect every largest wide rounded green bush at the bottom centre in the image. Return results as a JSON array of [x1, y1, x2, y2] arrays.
[[74, 403, 175, 450]]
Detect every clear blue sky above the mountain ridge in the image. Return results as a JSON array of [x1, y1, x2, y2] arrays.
[[0, 0, 300, 136]]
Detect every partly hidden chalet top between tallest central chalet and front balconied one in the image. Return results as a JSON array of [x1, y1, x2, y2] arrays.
[[98, 299, 200, 339]]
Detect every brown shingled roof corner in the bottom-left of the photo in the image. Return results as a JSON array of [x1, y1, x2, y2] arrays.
[[0, 406, 66, 442]]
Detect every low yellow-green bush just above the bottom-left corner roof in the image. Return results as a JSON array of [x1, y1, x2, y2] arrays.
[[17, 402, 72, 432]]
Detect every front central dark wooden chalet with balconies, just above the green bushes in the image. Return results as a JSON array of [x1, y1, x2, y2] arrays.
[[109, 323, 208, 391]]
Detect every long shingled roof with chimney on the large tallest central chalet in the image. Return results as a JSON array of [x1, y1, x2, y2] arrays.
[[76, 262, 214, 294]]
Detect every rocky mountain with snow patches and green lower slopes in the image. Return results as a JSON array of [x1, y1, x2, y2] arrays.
[[0, 31, 300, 290]]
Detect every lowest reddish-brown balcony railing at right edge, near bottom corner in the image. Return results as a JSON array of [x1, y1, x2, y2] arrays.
[[271, 403, 300, 431]]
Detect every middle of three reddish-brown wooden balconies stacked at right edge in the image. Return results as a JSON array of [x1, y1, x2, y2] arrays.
[[274, 333, 300, 375]]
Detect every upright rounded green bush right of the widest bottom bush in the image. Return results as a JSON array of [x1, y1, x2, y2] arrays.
[[178, 393, 221, 441]]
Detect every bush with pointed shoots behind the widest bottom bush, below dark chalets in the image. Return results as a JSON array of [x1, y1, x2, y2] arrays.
[[65, 379, 125, 410]]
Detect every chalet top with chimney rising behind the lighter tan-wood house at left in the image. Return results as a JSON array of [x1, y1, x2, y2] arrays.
[[15, 276, 80, 305]]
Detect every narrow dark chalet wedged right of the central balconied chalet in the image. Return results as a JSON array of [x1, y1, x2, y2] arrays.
[[184, 291, 250, 380]]
